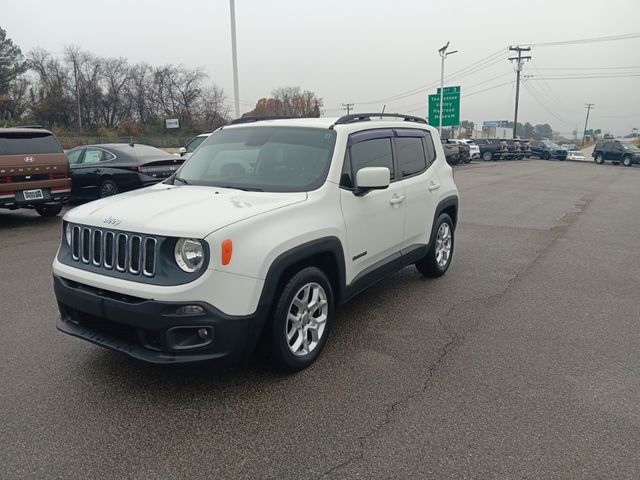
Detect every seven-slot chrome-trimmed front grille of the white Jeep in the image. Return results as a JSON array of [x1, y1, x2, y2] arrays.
[[70, 225, 158, 277]]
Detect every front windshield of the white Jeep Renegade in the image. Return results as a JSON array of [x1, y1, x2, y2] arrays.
[[177, 126, 336, 192]]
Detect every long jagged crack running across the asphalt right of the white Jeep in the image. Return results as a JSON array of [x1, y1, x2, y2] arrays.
[[317, 188, 613, 479]]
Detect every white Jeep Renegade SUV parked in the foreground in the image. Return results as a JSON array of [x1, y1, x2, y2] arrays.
[[53, 113, 458, 371]]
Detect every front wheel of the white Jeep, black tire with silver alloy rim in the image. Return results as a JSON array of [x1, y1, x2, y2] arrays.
[[270, 267, 334, 372]]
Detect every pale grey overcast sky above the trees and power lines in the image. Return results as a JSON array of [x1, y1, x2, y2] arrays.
[[0, 0, 640, 134]]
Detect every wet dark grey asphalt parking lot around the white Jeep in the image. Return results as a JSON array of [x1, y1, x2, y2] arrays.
[[0, 160, 640, 479]]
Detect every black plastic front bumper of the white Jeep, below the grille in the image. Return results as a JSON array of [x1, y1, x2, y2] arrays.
[[53, 275, 265, 364]]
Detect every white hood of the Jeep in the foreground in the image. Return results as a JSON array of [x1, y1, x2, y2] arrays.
[[65, 183, 307, 238]]
